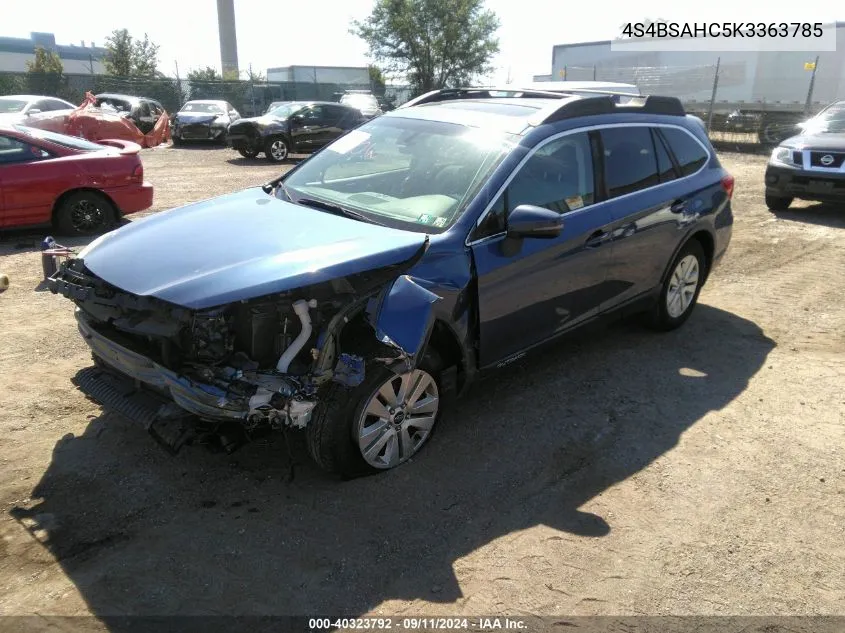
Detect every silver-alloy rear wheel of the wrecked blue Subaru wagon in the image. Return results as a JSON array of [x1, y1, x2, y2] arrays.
[[649, 240, 707, 331]]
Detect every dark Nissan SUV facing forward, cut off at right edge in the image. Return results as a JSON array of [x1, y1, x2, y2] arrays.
[[766, 101, 845, 211]]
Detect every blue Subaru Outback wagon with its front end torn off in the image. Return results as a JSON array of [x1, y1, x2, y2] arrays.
[[50, 89, 734, 476]]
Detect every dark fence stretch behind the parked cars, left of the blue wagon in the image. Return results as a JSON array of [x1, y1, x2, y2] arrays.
[[0, 72, 411, 116]]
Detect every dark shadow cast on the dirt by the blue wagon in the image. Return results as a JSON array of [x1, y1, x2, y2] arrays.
[[11, 305, 775, 632]]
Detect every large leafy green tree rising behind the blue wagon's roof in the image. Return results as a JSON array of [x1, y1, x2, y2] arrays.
[[351, 0, 499, 93]]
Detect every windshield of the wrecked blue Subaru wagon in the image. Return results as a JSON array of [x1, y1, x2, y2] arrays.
[[276, 117, 517, 233]]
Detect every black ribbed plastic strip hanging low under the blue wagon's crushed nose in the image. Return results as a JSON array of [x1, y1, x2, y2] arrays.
[[74, 360, 197, 455]]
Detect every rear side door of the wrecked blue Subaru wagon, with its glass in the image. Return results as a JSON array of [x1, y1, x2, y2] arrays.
[[600, 125, 709, 309]]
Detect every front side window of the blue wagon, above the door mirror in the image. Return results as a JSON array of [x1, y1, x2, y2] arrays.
[[470, 132, 595, 240]]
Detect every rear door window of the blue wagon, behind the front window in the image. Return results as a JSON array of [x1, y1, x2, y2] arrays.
[[601, 127, 660, 198]]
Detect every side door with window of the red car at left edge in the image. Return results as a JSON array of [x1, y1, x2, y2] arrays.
[[0, 133, 66, 227]]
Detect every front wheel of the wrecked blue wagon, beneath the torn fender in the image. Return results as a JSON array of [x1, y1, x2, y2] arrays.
[[306, 355, 442, 478]]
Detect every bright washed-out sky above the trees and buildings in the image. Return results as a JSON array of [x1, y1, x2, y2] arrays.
[[0, 0, 845, 83]]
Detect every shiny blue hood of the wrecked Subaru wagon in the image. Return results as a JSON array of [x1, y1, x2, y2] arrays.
[[79, 187, 426, 309]]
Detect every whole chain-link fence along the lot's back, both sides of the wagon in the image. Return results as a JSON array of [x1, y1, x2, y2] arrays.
[[0, 62, 832, 149]]
